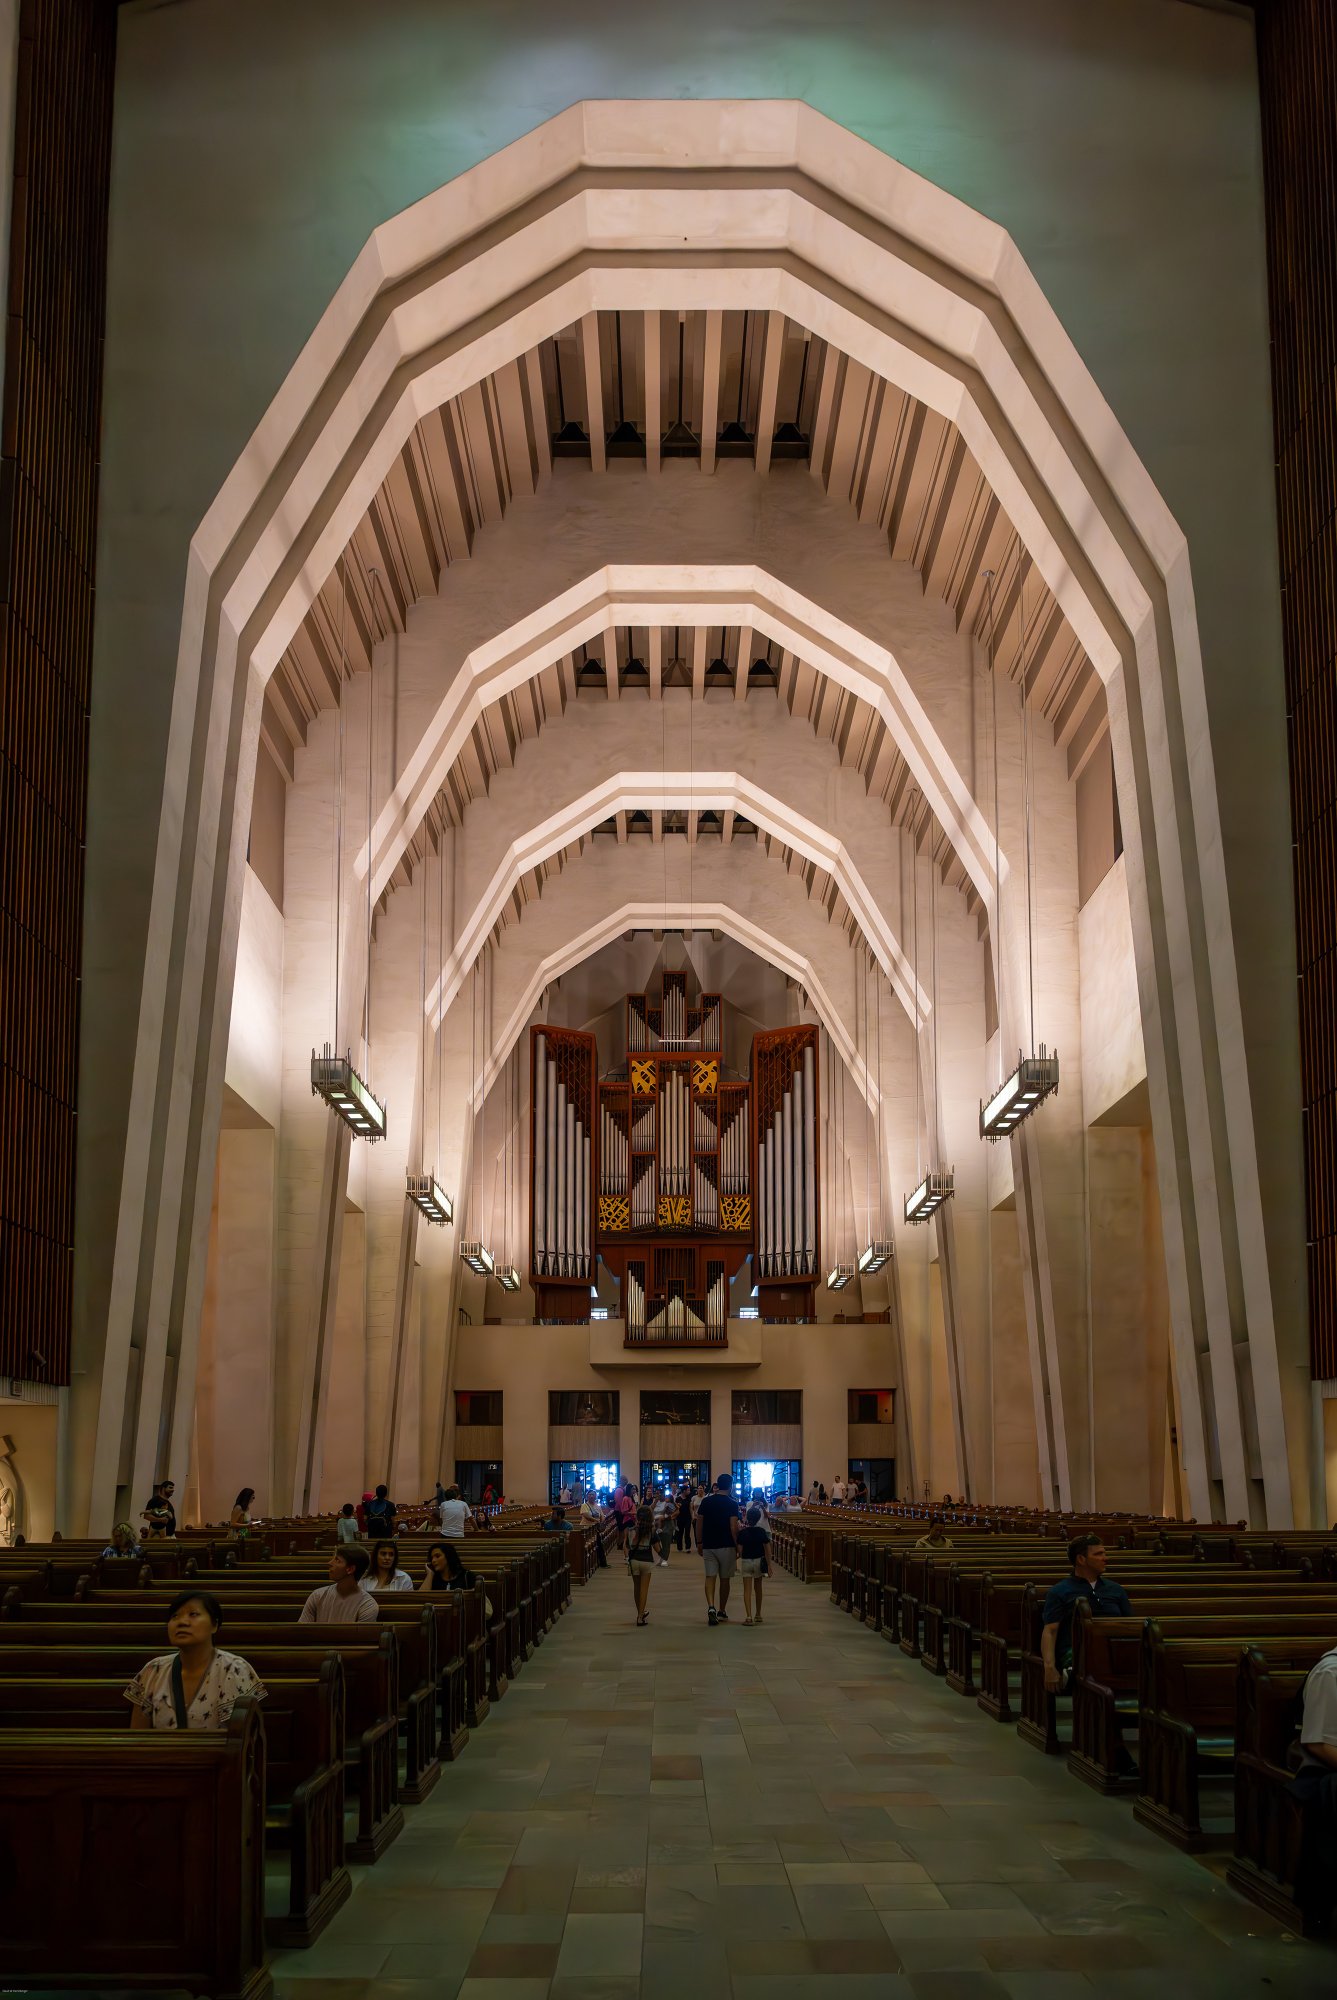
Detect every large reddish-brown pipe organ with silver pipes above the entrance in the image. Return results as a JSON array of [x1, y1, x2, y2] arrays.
[[530, 972, 821, 1346]]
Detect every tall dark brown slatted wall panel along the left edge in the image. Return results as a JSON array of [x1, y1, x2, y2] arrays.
[[0, 0, 116, 1382]]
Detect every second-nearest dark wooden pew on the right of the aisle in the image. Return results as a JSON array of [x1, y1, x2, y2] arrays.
[[1133, 1616, 1337, 1852]]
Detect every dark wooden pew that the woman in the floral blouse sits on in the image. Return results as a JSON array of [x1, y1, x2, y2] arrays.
[[0, 1654, 352, 1946]]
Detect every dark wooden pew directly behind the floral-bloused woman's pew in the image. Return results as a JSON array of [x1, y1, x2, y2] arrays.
[[0, 1616, 404, 1862]]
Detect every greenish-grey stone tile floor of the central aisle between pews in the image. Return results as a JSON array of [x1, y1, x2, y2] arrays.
[[274, 1556, 1337, 2000]]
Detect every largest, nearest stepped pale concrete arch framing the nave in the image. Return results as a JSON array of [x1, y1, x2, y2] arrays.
[[81, 102, 1303, 1524]]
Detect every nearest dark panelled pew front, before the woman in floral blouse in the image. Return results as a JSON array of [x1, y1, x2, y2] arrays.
[[0, 1702, 274, 2000]]
